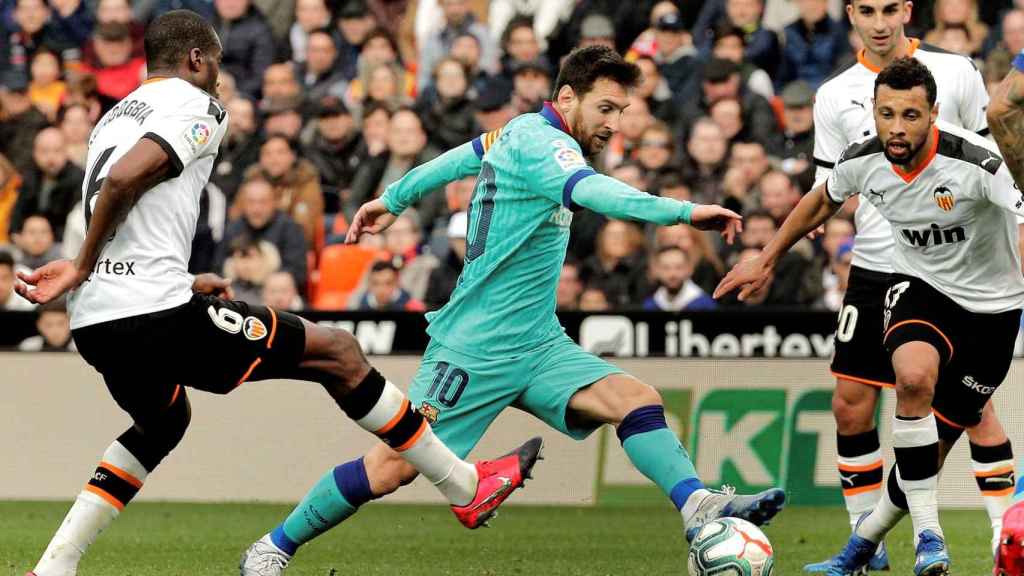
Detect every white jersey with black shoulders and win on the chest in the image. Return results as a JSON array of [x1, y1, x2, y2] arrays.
[[825, 122, 1024, 314]]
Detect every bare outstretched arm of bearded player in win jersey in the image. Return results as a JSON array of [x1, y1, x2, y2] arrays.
[[715, 182, 843, 300]]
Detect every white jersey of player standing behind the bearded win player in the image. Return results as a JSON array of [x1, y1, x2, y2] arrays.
[[814, 39, 988, 273]]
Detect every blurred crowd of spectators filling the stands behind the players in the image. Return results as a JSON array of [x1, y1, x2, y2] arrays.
[[0, 0, 1024, 334]]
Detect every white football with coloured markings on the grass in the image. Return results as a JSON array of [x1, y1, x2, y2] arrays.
[[687, 518, 775, 576]]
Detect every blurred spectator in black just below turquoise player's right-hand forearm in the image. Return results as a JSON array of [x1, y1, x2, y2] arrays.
[[582, 220, 648, 307]]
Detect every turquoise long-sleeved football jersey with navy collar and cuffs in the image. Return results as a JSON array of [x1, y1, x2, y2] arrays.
[[381, 102, 692, 358]]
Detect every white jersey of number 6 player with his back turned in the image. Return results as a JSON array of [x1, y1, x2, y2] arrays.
[[70, 78, 227, 328]]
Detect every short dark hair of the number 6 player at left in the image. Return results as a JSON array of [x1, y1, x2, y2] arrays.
[[145, 10, 220, 70]]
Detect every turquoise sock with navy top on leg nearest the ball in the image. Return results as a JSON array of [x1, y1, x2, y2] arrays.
[[616, 405, 703, 509]]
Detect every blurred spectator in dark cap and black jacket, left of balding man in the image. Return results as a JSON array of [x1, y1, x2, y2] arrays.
[[303, 96, 364, 196]]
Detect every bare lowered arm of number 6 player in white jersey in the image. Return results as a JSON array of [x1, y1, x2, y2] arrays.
[[15, 137, 173, 303]]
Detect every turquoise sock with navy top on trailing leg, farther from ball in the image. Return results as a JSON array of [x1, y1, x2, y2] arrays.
[[270, 458, 373, 554]]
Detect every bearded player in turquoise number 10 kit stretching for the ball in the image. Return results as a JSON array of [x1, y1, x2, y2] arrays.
[[242, 46, 785, 576]]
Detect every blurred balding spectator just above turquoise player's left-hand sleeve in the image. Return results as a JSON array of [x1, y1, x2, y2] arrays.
[[346, 109, 444, 230]]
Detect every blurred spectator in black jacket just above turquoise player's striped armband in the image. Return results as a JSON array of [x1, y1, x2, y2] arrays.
[[417, 57, 480, 150]]
